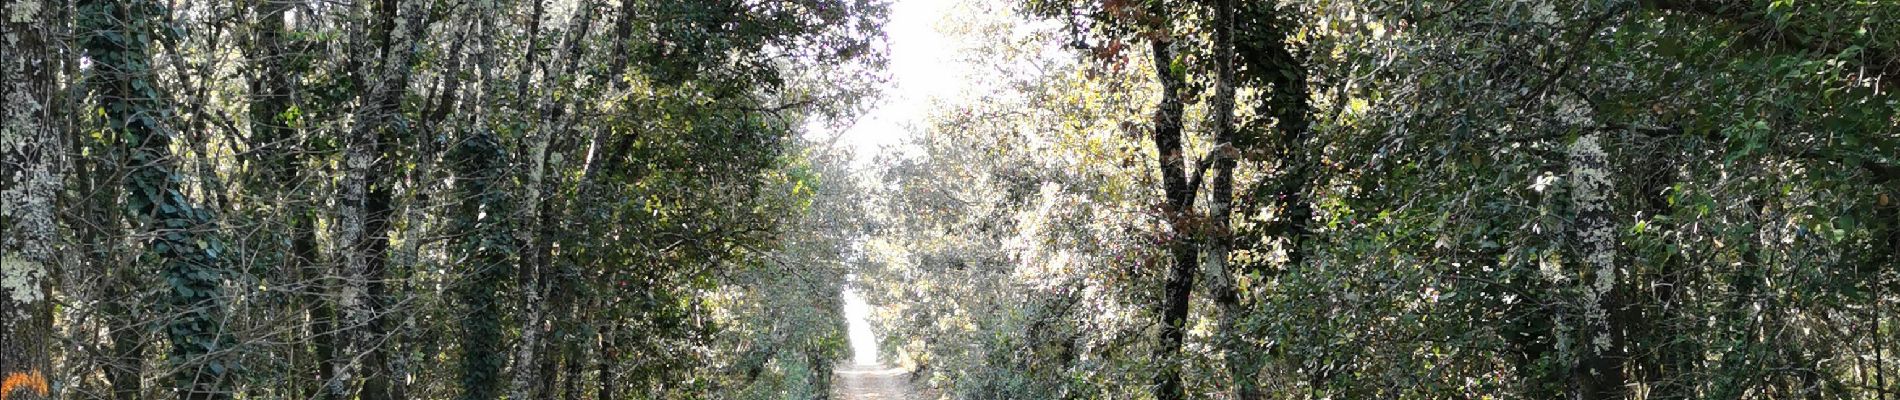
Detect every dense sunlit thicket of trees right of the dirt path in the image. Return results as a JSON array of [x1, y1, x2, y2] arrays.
[[863, 0, 1900, 400]]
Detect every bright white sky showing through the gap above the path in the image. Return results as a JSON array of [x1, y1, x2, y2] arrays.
[[836, 0, 965, 366]]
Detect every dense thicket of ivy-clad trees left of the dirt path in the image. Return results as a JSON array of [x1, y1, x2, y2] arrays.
[[0, 0, 884, 400]]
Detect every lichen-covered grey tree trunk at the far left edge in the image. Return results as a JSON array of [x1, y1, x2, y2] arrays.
[[0, 0, 67, 400]]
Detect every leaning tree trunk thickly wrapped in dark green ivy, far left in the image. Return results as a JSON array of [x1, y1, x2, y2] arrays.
[[78, 0, 232, 400]]
